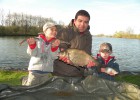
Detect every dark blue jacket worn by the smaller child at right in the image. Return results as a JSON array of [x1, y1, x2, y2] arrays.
[[96, 54, 120, 81]]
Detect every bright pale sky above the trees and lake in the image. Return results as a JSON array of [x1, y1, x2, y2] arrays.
[[0, 0, 140, 35]]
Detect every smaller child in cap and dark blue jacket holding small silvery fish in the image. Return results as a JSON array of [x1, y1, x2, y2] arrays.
[[95, 43, 120, 81]]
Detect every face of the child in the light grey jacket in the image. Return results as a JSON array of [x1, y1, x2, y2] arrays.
[[44, 26, 57, 38]]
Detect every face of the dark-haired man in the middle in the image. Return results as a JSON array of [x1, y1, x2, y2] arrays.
[[74, 15, 89, 32]]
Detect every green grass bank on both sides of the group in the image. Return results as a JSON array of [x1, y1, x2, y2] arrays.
[[0, 70, 140, 86]]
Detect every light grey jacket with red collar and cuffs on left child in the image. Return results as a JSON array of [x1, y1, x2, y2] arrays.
[[27, 34, 59, 72]]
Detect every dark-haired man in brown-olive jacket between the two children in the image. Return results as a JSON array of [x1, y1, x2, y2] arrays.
[[53, 10, 94, 77]]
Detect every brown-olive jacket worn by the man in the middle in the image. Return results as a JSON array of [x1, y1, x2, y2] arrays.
[[53, 20, 92, 76]]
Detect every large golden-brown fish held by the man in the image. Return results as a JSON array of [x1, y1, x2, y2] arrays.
[[59, 49, 101, 67]]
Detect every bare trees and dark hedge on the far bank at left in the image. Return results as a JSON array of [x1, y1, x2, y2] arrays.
[[0, 9, 64, 36]]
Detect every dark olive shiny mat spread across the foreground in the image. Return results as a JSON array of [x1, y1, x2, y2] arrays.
[[0, 75, 140, 100]]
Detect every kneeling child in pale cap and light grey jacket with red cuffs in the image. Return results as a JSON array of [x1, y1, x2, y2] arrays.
[[22, 22, 60, 86]]
